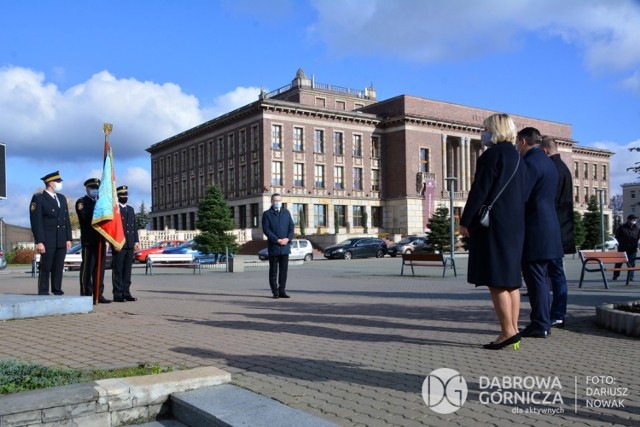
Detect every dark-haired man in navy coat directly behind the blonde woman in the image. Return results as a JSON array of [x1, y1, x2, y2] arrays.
[[516, 127, 563, 338]]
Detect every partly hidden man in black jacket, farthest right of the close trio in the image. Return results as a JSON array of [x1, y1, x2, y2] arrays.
[[540, 136, 576, 328]]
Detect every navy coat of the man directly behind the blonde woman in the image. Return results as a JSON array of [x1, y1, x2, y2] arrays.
[[522, 146, 564, 261]]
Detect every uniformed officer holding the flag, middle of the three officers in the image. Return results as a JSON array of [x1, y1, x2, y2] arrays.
[[76, 178, 111, 304]]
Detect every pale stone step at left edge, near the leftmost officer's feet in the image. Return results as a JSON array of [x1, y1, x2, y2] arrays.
[[0, 294, 93, 320]]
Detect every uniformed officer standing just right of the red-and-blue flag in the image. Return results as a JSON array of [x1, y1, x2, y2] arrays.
[[111, 185, 140, 302]]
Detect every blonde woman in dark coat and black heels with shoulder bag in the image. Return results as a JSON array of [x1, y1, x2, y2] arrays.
[[460, 114, 526, 350]]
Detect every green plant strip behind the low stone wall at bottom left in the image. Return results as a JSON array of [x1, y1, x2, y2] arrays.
[[0, 359, 173, 394]]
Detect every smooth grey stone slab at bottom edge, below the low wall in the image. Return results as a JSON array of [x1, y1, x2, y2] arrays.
[[171, 384, 337, 427]]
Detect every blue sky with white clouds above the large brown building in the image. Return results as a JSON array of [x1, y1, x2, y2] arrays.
[[0, 0, 640, 226]]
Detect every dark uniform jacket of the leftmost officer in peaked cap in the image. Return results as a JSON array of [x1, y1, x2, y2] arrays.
[[29, 191, 72, 248]]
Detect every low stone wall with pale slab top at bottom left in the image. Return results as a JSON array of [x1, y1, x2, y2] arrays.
[[0, 367, 231, 427]]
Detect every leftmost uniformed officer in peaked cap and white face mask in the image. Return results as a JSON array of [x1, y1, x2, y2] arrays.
[[29, 171, 72, 295]]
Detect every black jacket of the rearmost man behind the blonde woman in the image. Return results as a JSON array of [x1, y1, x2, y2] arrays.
[[549, 154, 576, 254]]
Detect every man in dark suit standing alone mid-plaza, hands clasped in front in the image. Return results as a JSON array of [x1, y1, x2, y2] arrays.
[[262, 193, 293, 299]]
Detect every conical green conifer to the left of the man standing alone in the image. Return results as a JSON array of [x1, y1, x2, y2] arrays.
[[194, 185, 238, 254]]
